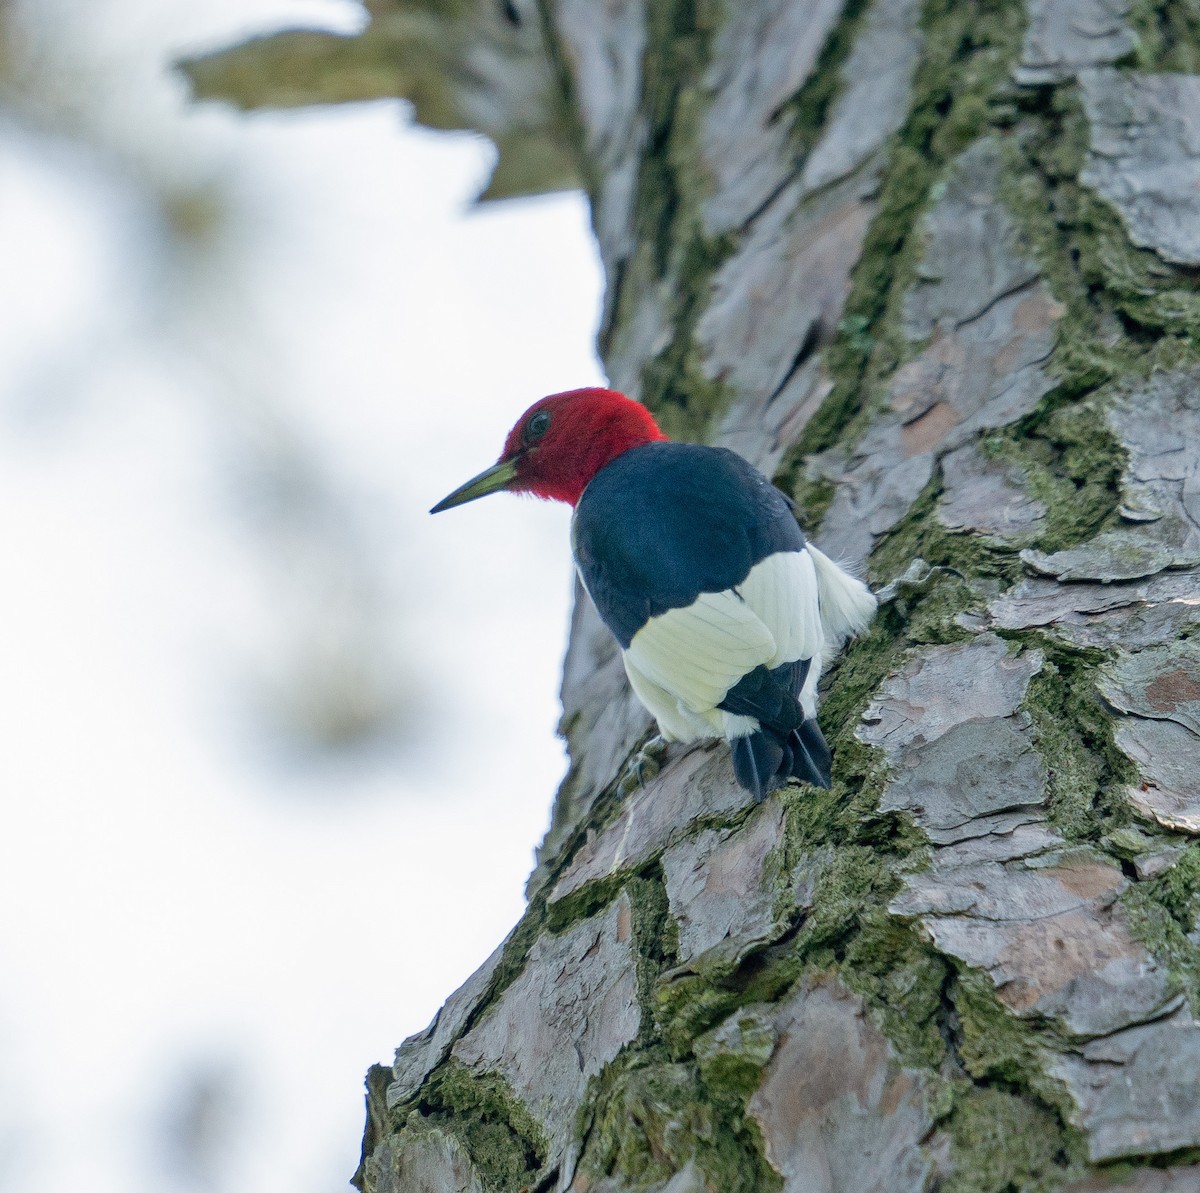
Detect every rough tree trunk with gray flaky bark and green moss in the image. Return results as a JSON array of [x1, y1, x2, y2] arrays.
[[188, 0, 1200, 1193]]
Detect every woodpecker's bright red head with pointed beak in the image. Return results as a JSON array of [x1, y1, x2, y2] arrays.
[[431, 389, 666, 514]]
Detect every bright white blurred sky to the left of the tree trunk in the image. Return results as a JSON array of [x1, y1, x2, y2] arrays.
[[0, 0, 600, 1193]]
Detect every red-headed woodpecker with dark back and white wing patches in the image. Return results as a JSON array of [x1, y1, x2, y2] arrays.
[[430, 386, 876, 803]]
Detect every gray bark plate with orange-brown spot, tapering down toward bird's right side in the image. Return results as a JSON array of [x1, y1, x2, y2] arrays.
[[818, 139, 1062, 559]]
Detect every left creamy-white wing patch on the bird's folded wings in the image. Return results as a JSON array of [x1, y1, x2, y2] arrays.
[[626, 592, 775, 713]]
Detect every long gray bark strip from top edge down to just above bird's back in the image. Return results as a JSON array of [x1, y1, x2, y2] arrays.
[[696, 0, 920, 475]]
